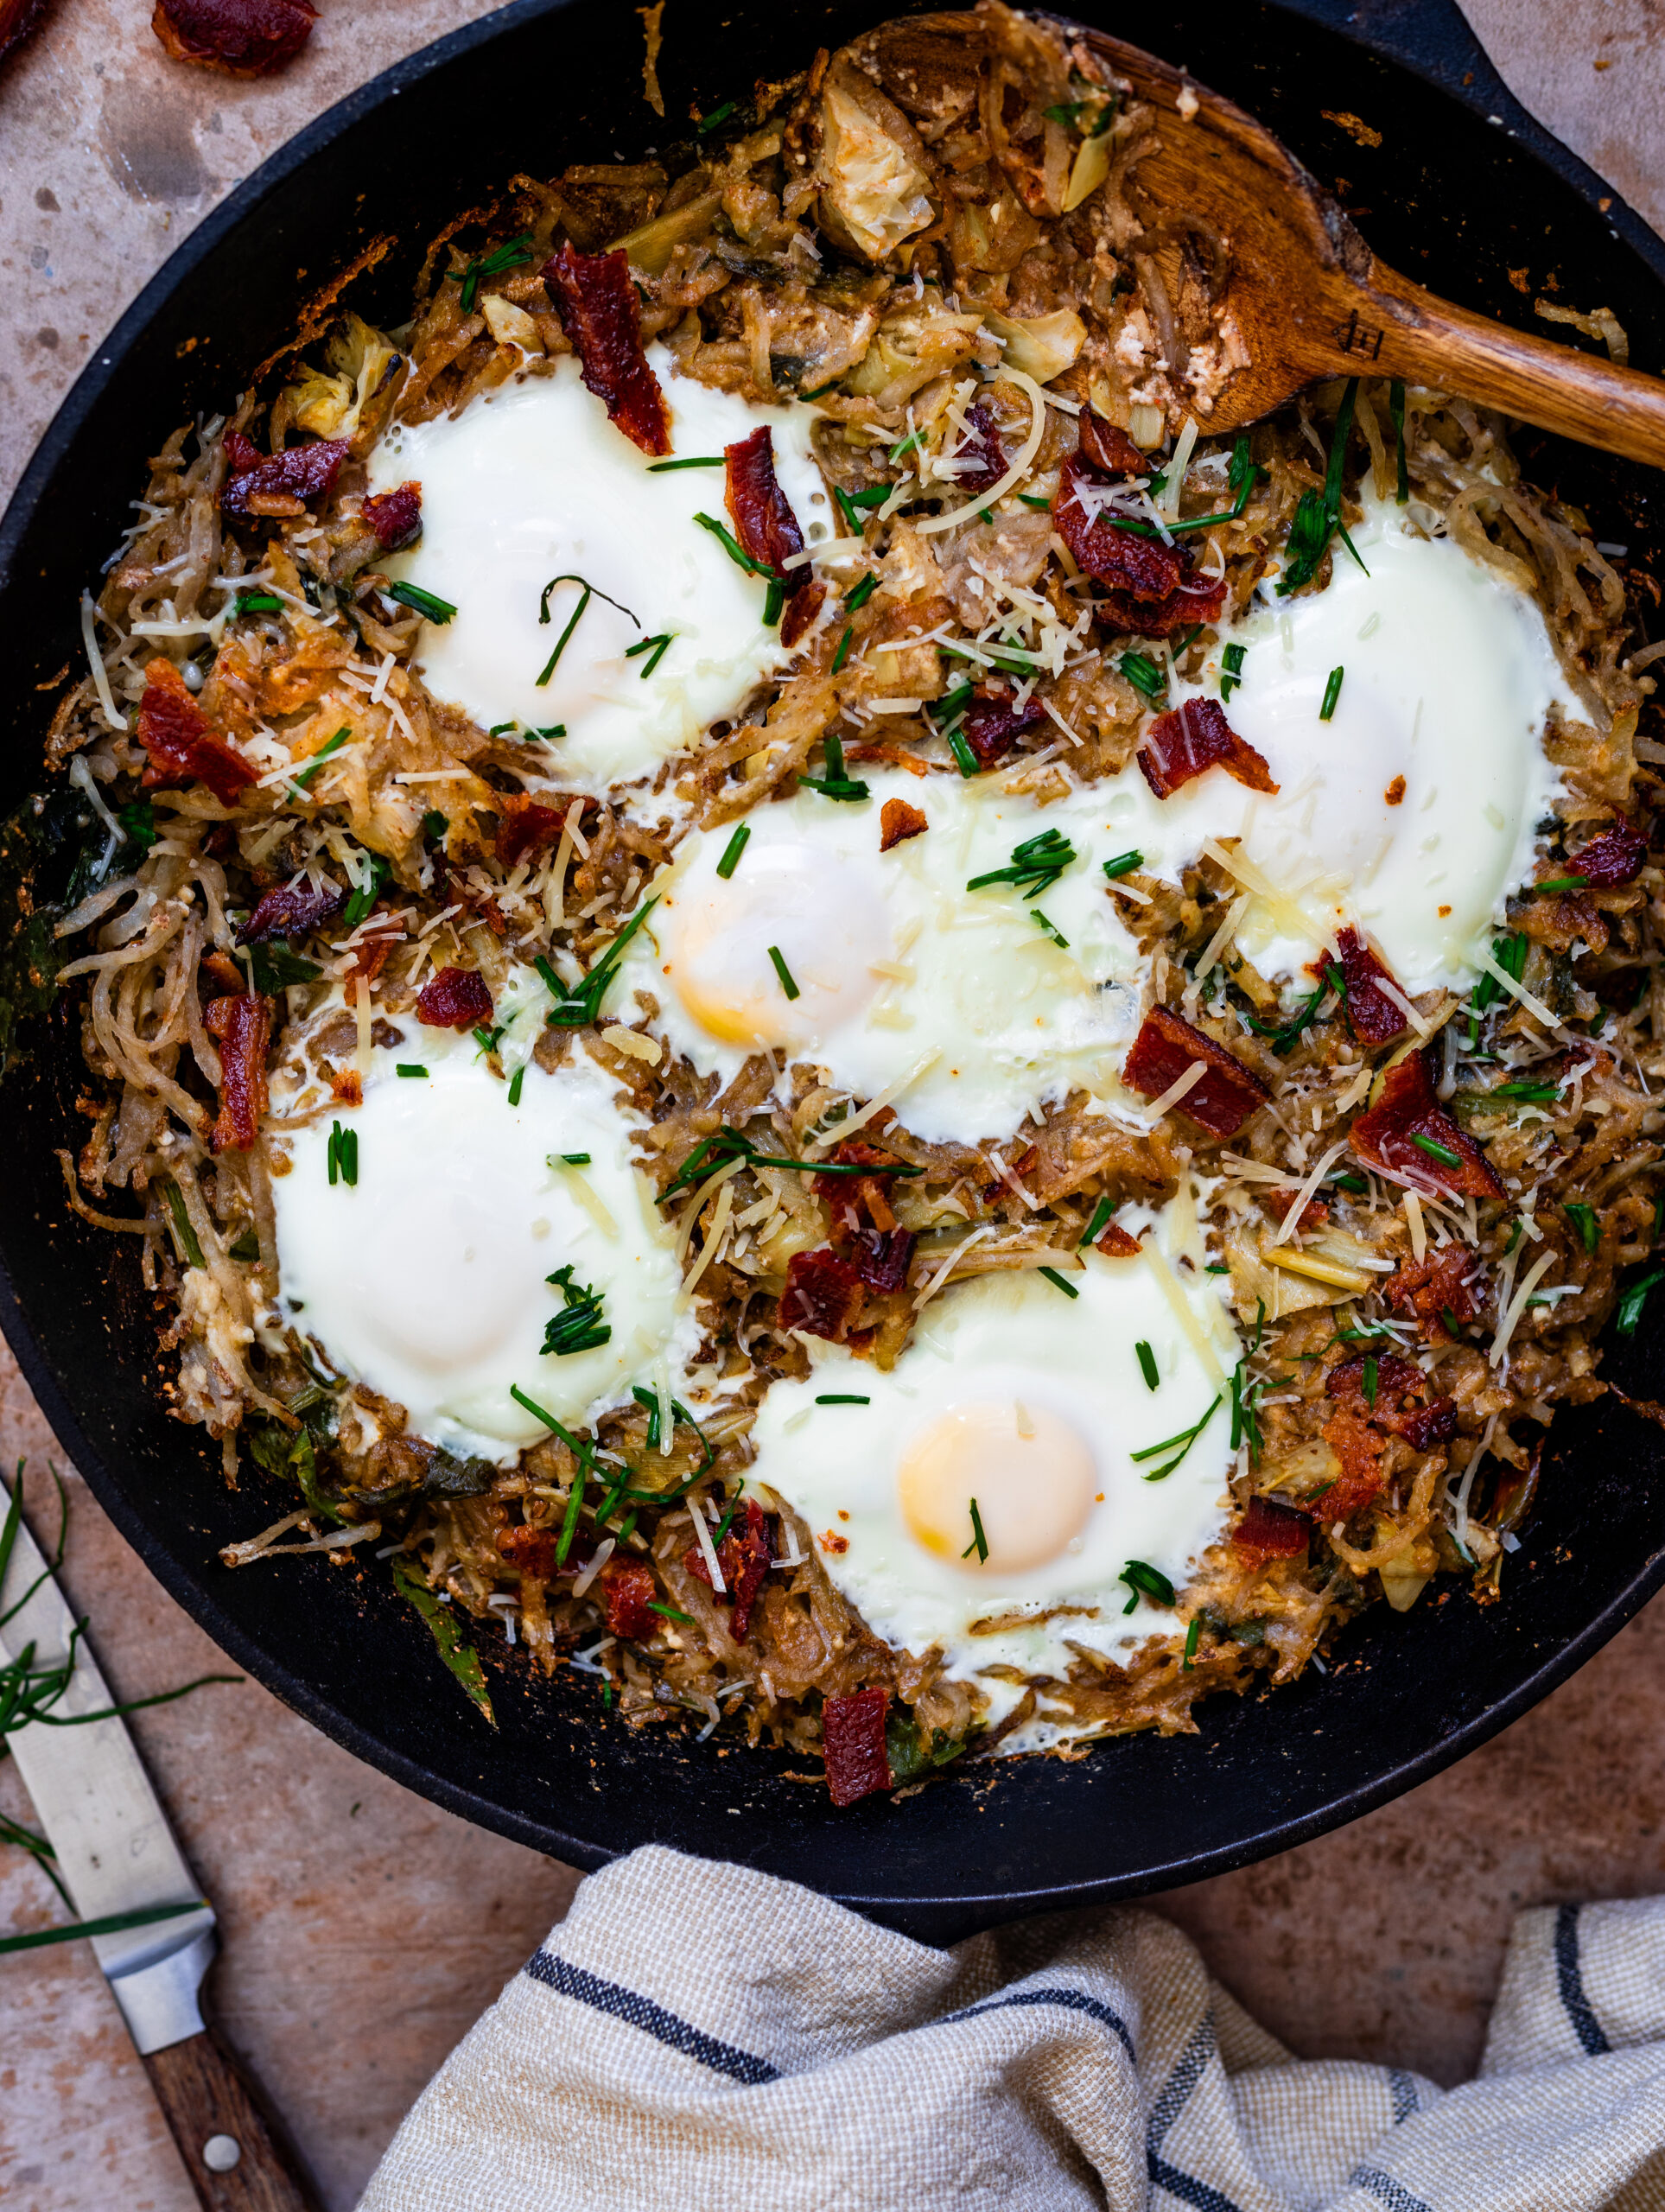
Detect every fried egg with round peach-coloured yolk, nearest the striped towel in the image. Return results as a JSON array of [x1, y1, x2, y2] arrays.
[[747, 1199, 1238, 1750]]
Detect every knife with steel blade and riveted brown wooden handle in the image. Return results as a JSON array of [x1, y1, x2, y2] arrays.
[[0, 1482, 323, 2212]]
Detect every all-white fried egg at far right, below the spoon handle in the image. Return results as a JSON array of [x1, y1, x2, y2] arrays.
[[1083, 500, 1586, 991]]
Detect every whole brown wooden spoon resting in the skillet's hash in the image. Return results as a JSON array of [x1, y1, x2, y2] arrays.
[[1071, 24, 1665, 469]]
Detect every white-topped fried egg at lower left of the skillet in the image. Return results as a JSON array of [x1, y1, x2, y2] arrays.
[[272, 1000, 699, 1466]]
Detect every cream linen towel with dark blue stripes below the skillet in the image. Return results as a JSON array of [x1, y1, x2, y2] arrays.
[[360, 1847, 1665, 2212]]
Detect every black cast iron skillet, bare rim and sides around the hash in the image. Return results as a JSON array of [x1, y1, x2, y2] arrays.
[[0, 0, 1665, 1940]]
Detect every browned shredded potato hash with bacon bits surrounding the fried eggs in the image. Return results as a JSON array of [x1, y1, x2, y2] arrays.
[[26, 0, 1665, 1794]]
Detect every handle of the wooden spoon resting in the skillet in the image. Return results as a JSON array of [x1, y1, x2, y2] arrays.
[[1302, 261, 1665, 469]]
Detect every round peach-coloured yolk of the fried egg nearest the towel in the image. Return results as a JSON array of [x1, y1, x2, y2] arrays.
[[895, 1400, 1099, 1575]]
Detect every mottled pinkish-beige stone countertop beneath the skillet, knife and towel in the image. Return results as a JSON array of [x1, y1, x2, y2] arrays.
[[0, 0, 1665, 2212]]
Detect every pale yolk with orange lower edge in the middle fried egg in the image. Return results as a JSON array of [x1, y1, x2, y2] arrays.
[[657, 842, 891, 1048]]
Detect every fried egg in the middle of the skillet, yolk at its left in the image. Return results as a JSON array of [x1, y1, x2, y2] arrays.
[[608, 770, 1139, 1144]]
